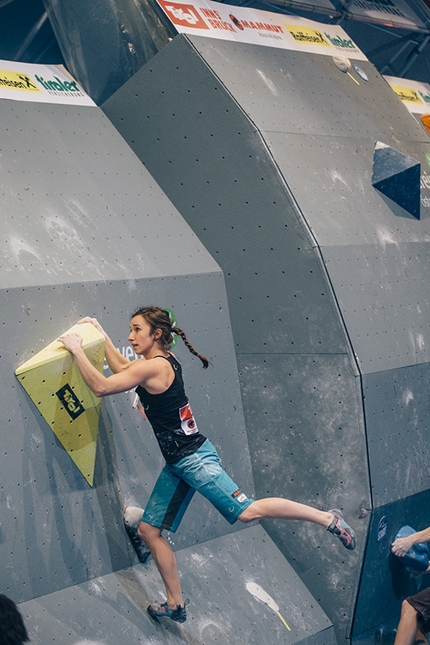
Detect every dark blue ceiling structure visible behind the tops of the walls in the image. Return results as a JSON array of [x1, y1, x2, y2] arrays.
[[0, 0, 430, 83]]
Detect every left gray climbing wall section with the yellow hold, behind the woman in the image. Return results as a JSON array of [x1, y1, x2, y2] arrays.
[[0, 61, 335, 645]]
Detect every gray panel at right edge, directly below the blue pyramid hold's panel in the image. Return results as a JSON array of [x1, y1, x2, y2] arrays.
[[322, 240, 430, 374]]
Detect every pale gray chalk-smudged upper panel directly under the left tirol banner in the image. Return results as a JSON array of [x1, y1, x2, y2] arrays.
[[0, 100, 217, 287]]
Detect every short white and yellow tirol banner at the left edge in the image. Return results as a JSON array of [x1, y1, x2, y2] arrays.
[[0, 60, 95, 105]]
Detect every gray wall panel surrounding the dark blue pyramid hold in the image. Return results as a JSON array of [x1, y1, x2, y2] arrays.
[[265, 132, 430, 244]]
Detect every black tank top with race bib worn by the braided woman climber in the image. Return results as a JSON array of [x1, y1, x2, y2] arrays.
[[136, 354, 206, 464]]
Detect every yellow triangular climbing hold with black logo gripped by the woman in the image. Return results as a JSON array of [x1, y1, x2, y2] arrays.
[[15, 323, 105, 486]]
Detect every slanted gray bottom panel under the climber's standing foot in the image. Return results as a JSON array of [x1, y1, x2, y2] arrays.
[[20, 526, 335, 645]]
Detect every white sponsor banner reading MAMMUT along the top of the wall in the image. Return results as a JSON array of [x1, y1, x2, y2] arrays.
[[157, 0, 367, 60]]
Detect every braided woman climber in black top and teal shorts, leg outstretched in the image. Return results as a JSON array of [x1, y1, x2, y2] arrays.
[[58, 306, 355, 623]]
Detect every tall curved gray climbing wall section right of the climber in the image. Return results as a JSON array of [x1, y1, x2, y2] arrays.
[[103, 17, 430, 642]]
